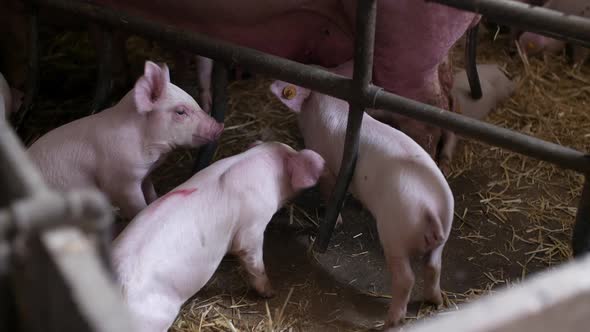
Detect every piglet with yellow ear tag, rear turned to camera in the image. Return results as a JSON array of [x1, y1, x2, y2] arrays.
[[270, 62, 454, 326]]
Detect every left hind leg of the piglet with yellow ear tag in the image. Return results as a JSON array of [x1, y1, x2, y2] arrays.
[[385, 253, 414, 327]]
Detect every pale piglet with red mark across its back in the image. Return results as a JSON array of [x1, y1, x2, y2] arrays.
[[112, 142, 325, 332]]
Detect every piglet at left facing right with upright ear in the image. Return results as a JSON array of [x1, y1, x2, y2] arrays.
[[28, 61, 223, 219]]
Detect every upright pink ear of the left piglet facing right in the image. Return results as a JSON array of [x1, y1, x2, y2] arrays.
[[133, 61, 170, 113]]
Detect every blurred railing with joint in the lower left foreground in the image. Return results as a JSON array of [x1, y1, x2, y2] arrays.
[[0, 119, 131, 332]]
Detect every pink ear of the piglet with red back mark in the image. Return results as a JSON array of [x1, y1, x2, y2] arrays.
[[287, 150, 326, 191]]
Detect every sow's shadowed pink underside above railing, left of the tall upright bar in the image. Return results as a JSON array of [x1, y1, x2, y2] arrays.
[[90, 0, 354, 67]]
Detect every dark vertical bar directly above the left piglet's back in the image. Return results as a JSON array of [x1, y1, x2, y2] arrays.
[[90, 24, 113, 114]]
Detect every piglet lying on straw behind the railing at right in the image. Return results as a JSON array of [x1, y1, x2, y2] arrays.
[[439, 64, 516, 174]]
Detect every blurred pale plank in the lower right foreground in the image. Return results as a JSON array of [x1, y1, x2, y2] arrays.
[[406, 255, 590, 332]]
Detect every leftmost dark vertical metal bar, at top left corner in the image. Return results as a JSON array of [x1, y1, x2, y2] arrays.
[[14, 0, 39, 133]]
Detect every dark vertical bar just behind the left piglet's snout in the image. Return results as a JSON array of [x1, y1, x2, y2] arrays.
[[193, 61, 229, 173]]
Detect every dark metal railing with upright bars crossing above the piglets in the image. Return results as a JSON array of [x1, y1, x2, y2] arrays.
[[15, 0, 590, 255]]
